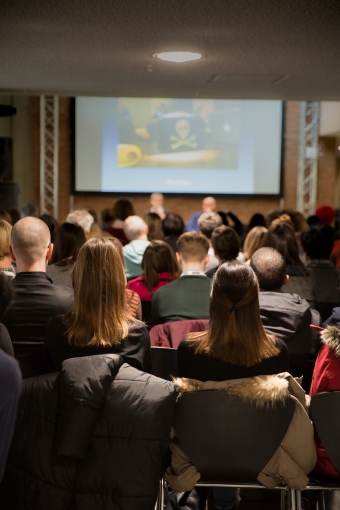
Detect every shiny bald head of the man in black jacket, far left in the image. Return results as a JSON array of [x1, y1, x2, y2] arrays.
[[11, 216, 51, 265]]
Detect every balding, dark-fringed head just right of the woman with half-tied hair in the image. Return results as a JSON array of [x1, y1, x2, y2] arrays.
[[250, 248, 286, 291]]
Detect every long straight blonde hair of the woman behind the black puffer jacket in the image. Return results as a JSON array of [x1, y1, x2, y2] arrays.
[[64, 238, 140, 347]]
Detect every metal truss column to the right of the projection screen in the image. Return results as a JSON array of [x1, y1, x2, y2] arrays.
[[296, 101, 319, 216]]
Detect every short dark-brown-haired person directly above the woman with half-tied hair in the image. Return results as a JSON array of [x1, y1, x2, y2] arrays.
[[207, 225, 243, 278]]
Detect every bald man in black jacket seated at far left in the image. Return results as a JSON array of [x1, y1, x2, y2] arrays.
[[2, 217, 73, 342]]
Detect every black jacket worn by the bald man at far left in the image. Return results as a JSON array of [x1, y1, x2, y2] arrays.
[[2, 272, 73, 342]]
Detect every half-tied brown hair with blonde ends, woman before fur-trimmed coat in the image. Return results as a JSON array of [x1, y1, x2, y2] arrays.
[[187, 260, 279, 367]]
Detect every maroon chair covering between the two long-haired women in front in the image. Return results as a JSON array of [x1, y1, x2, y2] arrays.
[[150, 319, 209, 349]]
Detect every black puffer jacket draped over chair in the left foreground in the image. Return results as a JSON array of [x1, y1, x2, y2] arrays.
[[0, 354, 177, 510]]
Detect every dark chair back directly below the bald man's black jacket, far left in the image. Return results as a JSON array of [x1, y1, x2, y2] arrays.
[[13, 342, 54, 379]]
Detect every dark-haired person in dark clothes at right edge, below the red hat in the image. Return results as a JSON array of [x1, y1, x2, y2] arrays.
[[301, 224, 340, 308]]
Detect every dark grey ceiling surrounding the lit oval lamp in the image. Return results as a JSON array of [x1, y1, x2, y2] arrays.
[[0, 0, 340, 100]]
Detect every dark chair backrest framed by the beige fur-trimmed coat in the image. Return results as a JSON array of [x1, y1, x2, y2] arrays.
[[174, 391, 295, 483]]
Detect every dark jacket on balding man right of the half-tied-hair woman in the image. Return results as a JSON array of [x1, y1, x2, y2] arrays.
[[260, 291, 320, 358]]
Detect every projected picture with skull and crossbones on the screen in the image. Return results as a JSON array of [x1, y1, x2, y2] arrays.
[[117, 98, 240, 169]]
